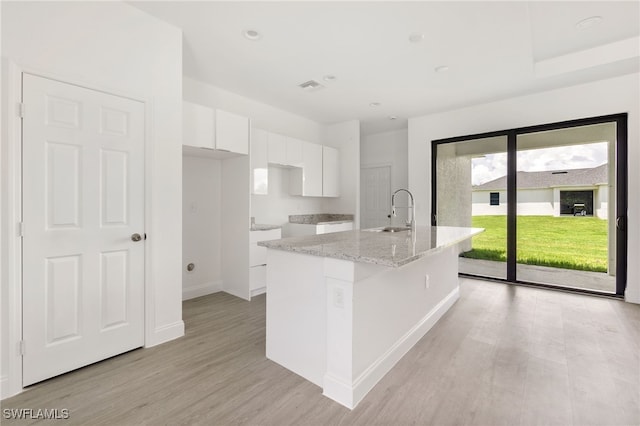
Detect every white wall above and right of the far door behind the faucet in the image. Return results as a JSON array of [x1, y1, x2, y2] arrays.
[[360, 129, 409, 225]]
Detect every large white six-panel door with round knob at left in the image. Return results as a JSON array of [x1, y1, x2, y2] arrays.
[[22, 74, 144, 386]]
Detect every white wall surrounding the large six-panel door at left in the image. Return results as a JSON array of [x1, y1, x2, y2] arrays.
[[1, 2, 184, 397]]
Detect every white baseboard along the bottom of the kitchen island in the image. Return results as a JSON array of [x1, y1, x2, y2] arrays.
[[322, 287, 460, 410]]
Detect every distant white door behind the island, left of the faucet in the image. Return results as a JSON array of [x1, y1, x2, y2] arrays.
[[360, 166, 391, 229]]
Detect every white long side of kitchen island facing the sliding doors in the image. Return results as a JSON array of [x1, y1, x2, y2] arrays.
[[324, 247, 459, 409]]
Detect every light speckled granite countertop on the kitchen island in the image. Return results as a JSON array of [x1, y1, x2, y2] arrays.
[[258, 226, 484, 267]]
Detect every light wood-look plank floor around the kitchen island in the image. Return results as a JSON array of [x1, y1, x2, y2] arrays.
[[2, 279, 640, 426]]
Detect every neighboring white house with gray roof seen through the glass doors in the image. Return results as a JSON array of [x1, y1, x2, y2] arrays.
[[471, 164, 609, 219]]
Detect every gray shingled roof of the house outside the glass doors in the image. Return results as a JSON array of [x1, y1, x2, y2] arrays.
[[473, 163, 608, 191]]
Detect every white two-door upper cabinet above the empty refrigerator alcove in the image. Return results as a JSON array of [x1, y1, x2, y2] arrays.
[[182, 101, 249, 155]]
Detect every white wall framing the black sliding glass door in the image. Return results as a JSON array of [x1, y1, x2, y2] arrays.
[[409, 74, 640, 303]]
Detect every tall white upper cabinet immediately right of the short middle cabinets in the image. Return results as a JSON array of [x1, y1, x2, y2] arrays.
[[289, 141, 322, 197]]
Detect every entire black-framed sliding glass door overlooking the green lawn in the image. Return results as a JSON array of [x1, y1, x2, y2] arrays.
[[432, 114, 627, 295]]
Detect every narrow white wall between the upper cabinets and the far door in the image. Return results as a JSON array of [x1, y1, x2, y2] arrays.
[[323, 120, 360, 229]]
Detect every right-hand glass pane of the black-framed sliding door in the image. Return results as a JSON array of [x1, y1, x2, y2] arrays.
[[516, 123, 616, 293]]
